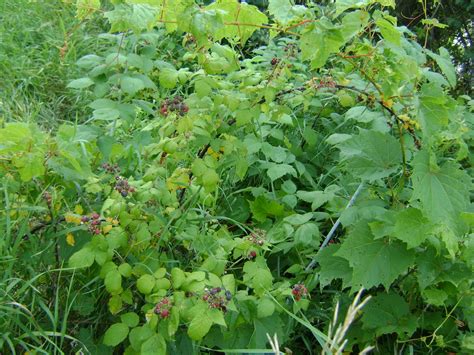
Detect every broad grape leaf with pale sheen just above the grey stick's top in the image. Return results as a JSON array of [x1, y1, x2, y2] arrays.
[[337, 131, 402, 181]]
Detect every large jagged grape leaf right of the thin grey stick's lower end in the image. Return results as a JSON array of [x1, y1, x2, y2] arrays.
[[335, 220, 414, 290]]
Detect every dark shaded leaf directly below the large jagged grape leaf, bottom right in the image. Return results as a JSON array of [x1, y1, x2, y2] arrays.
[[362, 292, 418, 336]]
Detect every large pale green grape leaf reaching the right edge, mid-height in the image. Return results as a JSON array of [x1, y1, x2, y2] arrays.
[[412, 151, 472, 236]]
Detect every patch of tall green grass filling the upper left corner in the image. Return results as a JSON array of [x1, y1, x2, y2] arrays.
[[0, 0, 105, 127]]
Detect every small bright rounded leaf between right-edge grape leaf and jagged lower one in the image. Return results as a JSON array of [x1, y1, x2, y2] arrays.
[[393, 208, 434, 249]]
